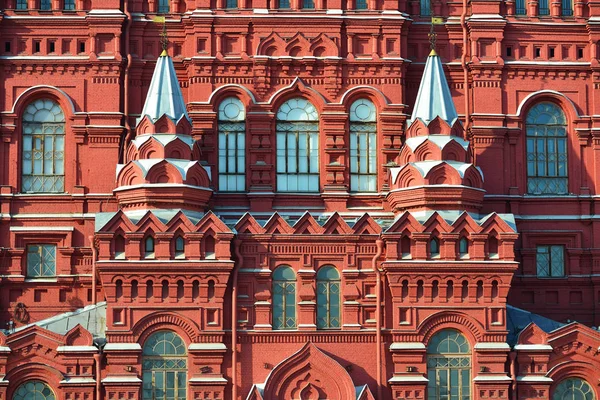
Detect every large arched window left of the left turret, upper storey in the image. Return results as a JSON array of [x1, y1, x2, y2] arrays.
[[22, 99, 65, 193]]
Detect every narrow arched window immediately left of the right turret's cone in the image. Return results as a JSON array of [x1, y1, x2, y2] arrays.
[[350, 99, 377, 192]]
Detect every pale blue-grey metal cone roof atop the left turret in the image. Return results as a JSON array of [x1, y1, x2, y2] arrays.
[[138, 55, 190, 123]]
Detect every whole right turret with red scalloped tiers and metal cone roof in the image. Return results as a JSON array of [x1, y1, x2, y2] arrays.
[[387, 50, 484, 211]]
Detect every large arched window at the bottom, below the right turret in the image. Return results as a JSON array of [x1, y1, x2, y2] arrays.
[[427, 329, 471, 400]]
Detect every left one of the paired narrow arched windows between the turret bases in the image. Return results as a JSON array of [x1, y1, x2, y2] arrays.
[[273, 266, 297, 329]]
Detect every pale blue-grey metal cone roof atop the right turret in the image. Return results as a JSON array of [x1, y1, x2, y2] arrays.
[[408, 51, 458, 126]]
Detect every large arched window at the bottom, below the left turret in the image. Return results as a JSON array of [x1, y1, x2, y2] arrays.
[[142, 331, 187, 400]]
